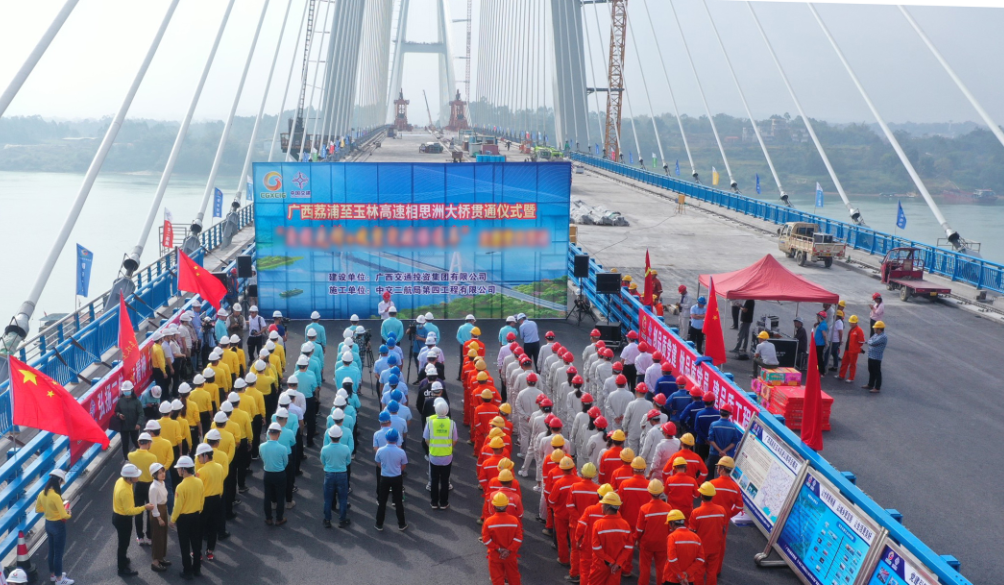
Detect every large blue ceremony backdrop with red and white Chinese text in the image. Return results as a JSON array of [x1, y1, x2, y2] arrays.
[[254, 163, 571, 319]]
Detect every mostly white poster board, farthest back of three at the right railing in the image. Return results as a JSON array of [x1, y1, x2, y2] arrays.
[[732, 415, 806, 536]]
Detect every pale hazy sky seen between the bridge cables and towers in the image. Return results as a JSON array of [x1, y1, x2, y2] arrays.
[[0, 0, 1004, 123]]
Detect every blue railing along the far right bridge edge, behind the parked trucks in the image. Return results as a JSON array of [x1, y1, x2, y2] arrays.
[[571, 153, 1004, 293]]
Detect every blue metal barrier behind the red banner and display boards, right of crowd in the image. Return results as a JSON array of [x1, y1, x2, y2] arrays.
[[568, 242, 970, 585]]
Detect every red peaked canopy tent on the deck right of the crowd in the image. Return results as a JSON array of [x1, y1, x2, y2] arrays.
[[701, 254, 840, 304]]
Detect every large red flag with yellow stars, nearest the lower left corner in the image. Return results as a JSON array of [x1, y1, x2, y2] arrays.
[[10, 357, 108, 448]]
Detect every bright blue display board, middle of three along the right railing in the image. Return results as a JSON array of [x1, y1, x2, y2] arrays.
[[777, 469, 880, 585]]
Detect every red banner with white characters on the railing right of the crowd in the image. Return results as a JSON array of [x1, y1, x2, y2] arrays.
[[638, 309, 759, 427]]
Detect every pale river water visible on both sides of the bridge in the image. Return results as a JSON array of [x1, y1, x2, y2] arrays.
[[0, 167, 1004, 331]]
